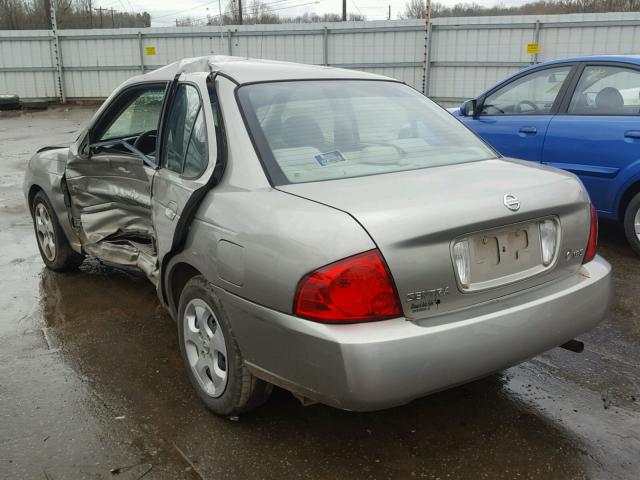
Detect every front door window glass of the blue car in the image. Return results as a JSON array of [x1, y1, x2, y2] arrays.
[[481, 66, 571, 115]]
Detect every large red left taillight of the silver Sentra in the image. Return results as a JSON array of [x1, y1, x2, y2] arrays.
[[293, 250, 402, 323]]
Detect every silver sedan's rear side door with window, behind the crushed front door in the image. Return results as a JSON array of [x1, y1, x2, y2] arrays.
[[152, 73, 220, 265]]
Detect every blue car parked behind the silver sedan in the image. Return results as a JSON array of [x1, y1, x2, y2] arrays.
[[452, 55, 640, 254]]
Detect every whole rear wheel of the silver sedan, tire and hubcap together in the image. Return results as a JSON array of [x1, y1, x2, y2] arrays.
[[177, 275, 273, 417]]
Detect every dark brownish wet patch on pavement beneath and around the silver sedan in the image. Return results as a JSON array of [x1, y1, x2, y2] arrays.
[[12, 260, 586, 478]]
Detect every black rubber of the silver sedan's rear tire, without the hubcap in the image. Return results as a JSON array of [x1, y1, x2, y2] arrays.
[[177, 275, 273, 417]]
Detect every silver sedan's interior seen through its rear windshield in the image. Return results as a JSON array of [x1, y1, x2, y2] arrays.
[[248, 84, 488, 183]]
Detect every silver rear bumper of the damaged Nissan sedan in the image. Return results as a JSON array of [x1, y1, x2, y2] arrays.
[[219, 257, 611, 411]]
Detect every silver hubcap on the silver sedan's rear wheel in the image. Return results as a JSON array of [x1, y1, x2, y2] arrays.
[[182, 298, 228, 398]]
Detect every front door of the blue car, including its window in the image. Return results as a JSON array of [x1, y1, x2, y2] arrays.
[[461, 65, 573, 162]]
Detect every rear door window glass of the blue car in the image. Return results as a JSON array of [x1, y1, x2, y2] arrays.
[[569, 65, 640, 115]]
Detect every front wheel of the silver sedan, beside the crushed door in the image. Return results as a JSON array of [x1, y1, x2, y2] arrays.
[[31, 191, 84, 272]]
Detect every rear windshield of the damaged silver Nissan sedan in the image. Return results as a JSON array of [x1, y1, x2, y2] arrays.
[[238, 80, 496, 185]]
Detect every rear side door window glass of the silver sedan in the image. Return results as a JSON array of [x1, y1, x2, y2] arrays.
[[161, 84, 208, 177]]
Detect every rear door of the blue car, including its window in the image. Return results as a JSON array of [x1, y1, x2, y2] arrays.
[[543, 62, 640, 216]]
